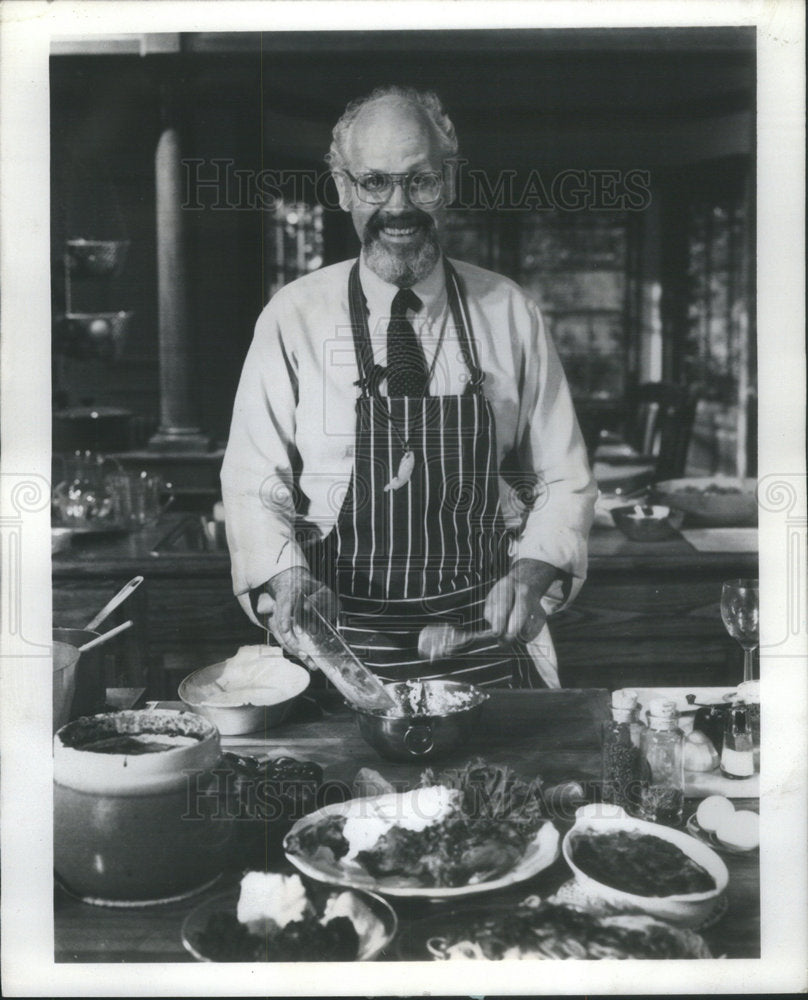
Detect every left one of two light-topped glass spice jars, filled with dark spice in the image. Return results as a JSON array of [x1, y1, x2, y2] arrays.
[[601, 689, 645, 813]]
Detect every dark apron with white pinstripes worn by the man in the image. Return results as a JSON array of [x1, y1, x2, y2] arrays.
[[312, 261, 543, 687]]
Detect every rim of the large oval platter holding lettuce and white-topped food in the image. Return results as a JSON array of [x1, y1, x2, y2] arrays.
[[284, 796, 559, 899]]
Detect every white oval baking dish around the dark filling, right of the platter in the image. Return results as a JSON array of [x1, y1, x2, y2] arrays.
[[562, 818, 729, 927]]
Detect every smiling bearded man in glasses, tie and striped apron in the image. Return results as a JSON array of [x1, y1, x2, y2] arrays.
[[222, 87, 596, 686]]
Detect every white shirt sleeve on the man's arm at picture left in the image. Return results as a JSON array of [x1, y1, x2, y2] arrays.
[[221, 294, 307, 617]]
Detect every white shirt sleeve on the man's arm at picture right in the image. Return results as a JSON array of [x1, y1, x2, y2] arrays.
[[514, 302, 597, 612]]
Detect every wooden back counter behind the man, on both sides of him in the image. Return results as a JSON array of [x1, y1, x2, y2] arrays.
[[53, 514, 757, 698]]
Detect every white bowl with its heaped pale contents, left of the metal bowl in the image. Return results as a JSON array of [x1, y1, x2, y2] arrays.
[[178, 646, 310, 736]]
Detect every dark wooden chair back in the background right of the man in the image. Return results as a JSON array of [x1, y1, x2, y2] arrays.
[[625, 382, 697, 480]]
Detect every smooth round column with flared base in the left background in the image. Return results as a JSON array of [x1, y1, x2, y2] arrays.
[[149, 125, 210, 452]]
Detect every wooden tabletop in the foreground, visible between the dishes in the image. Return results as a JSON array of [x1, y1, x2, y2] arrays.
[[55, 690, 760, 962]]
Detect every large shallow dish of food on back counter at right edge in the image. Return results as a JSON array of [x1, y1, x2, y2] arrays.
[[653, 476, 757, 528]]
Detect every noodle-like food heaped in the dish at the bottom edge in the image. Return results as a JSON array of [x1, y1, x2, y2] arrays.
[[426, 902, 712, 961]]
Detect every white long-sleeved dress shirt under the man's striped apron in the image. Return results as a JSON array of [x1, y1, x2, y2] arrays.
[[221, 258, 597, 617]]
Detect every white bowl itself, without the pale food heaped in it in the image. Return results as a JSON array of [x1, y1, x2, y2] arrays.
[[177, 655, 311, 736]]
